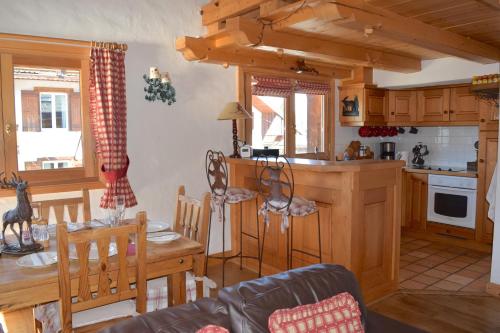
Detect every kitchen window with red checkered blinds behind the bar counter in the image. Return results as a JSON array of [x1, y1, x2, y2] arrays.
[[244, 73, 333, 159]]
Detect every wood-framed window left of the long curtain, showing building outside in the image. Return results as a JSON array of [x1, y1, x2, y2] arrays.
[[0, 36, 98, 190]]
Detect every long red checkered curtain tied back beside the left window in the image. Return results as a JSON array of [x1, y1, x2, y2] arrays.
[[90, 47, 137, 208]]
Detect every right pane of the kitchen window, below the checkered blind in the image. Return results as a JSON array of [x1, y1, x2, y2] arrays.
[[295, 94, 325, 154]]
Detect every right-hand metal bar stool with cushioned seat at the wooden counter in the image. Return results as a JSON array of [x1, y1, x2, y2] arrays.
[[255, 156, 322, 271]]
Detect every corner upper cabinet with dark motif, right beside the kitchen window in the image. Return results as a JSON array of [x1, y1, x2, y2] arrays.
[[339, 84, 387, 126]]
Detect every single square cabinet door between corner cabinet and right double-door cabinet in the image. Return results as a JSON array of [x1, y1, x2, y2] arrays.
[[388, 90, 417, 124]]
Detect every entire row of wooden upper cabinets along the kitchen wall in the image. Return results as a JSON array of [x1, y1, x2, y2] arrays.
[[340, 84, 480, 126]]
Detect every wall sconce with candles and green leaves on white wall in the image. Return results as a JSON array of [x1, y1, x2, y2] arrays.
[[143, 67, 175, 105]]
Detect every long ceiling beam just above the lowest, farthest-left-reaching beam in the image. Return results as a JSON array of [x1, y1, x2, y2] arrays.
[[210, 17, 421, 73]]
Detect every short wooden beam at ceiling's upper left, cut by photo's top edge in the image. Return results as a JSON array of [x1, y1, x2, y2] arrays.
[[201, 0, 269, 26]]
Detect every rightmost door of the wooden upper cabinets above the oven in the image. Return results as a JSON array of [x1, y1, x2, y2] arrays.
[[449, 85, 479, 122]]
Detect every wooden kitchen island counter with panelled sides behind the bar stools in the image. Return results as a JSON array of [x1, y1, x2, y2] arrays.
[[228, 158, 404, 302]]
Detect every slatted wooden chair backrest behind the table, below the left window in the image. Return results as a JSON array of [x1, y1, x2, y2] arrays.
[[32, 189, 91, 223]]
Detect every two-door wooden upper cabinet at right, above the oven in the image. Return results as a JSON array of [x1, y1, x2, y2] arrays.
[[417, 85, 479, 125]]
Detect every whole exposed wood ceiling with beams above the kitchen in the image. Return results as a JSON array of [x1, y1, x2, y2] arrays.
[[177, 0, 500, 78]]
